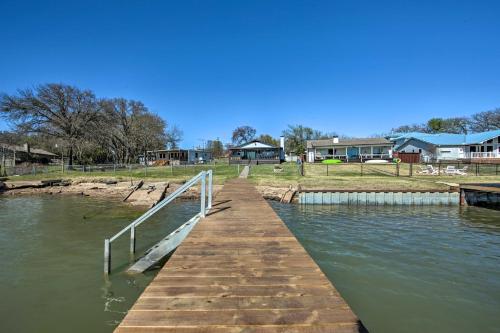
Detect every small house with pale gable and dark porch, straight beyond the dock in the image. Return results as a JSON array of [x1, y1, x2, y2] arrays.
[[229, 137, 285, 164]]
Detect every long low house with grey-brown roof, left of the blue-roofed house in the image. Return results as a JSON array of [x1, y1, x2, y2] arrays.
[[307, 137, 392, 163]]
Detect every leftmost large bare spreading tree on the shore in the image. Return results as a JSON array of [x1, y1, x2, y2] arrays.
[[0, 83, 99, 165]]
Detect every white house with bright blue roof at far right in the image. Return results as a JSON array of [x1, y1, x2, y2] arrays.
[[390, 130, 500, 162]]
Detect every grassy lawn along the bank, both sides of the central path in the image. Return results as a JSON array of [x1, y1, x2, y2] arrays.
[[4, 162, 500, 190]]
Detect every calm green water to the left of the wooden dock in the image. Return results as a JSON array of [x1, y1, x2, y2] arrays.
[[0, 196, 199, 333]]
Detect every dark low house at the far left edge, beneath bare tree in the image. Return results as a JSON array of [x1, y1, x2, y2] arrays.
[[0, 143, 57, 167]]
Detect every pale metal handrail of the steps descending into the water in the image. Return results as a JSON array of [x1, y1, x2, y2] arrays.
[[104, 170, 213, 274]]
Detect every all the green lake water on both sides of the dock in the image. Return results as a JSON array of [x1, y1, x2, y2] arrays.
[[0, 196, 500, 333]]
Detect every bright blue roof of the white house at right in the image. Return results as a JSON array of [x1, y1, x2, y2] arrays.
[[391, 130, 500, 146]]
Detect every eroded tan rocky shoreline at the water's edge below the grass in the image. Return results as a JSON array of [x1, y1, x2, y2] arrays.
[[0, 179, 296, 208]]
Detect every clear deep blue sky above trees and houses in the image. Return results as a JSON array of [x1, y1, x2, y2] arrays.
[[0, 0, 500, 147]]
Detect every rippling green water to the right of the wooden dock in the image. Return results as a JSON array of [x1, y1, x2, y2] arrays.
[[272, 203, 500, 333]]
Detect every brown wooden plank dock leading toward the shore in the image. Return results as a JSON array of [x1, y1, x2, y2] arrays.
[[115, 179, 366, 333]]
